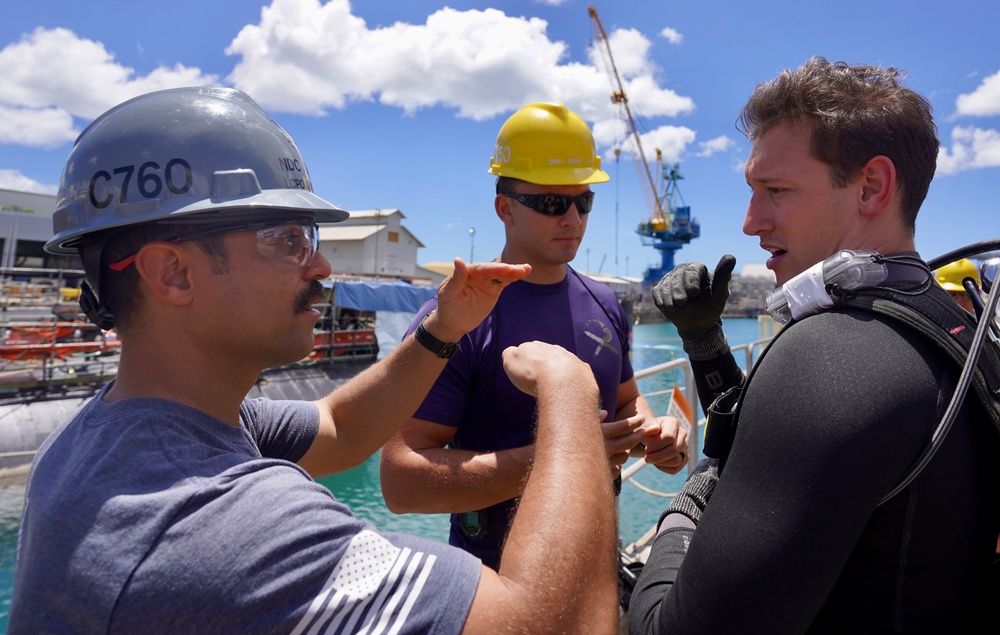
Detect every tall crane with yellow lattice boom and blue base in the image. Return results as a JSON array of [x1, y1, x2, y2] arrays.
[[587, 4, 701, 288]]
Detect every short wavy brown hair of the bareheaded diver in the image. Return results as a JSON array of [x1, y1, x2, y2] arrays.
[[737, 57, 939, 232]]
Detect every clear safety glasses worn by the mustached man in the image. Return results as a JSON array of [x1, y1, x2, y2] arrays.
[[109, 221, 319, 271]]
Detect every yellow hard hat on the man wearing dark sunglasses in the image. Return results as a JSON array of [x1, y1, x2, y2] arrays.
[[489, 102, 610, 185]]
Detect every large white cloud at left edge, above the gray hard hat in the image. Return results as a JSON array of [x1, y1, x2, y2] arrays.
[[0, 28, 216, 147]]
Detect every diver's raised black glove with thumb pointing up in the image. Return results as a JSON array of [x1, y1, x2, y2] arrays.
[[653, 254, 736, 361]]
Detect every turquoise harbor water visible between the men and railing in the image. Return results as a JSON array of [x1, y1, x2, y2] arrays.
[[0, 319, 758, 632]]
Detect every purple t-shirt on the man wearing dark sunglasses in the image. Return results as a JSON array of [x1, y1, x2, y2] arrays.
[[410, 270, 633, 568]]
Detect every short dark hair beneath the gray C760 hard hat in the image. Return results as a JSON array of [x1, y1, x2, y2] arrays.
[[80, 223, 229, 331]]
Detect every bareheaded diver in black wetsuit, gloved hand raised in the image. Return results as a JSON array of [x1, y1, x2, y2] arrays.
[[630, 58, 1000, 634]]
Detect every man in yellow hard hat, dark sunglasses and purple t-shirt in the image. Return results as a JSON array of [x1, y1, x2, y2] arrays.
[[381, 103, 687, 567]]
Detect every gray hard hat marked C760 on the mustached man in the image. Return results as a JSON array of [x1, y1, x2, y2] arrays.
[[45, 87, 348, 254]]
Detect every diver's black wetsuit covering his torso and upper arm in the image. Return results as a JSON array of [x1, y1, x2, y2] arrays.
[[630, 272, 1000, 635]]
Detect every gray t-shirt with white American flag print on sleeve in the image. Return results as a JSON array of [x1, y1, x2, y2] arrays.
[[8, 388, 481, 634]]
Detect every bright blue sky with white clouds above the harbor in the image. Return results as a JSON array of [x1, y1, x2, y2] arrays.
[[0, 0, 1000, 276]]
